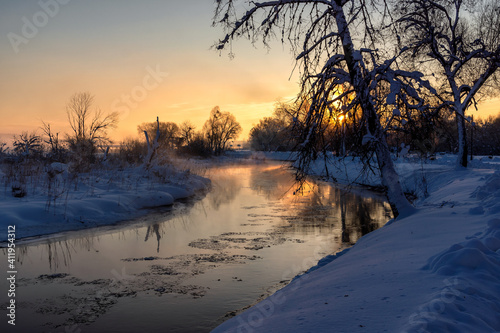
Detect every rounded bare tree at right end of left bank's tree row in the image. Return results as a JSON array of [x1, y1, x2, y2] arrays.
[[203, 106, 241, 155]]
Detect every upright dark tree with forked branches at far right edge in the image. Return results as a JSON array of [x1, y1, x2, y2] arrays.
[[394, 0, 500, 167]]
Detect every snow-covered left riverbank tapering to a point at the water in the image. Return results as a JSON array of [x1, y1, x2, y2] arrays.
[[0, 163, 210, 241]]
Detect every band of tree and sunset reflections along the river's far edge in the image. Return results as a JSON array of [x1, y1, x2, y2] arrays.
[[7, 165, 391, 271]]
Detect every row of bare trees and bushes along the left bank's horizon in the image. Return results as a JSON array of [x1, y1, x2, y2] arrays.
[[0, 92, 242, 171]]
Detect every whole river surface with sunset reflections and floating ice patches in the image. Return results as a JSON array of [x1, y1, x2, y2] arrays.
[[0, 163, 390, 333]]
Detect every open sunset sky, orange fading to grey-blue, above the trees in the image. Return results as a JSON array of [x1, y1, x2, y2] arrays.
[[0, 0, 500, 141]]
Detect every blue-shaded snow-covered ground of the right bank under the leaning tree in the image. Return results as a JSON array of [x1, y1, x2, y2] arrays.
[[213, 154, 500, 333]]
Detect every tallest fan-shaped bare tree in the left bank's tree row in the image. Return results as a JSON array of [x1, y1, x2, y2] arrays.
[[66, 92, 118, 155]]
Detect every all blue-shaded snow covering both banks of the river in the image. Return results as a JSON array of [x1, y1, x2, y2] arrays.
[[0, 151, 500, 333]]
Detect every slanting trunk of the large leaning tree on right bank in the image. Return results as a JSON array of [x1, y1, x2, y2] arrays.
[[332, 0, 414, 218]]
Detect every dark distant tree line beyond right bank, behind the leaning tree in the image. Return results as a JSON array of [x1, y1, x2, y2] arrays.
[[249, 97, 500, 158]]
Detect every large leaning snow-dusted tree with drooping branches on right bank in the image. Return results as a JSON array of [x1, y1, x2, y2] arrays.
[[214, 0, 436, 217]]
